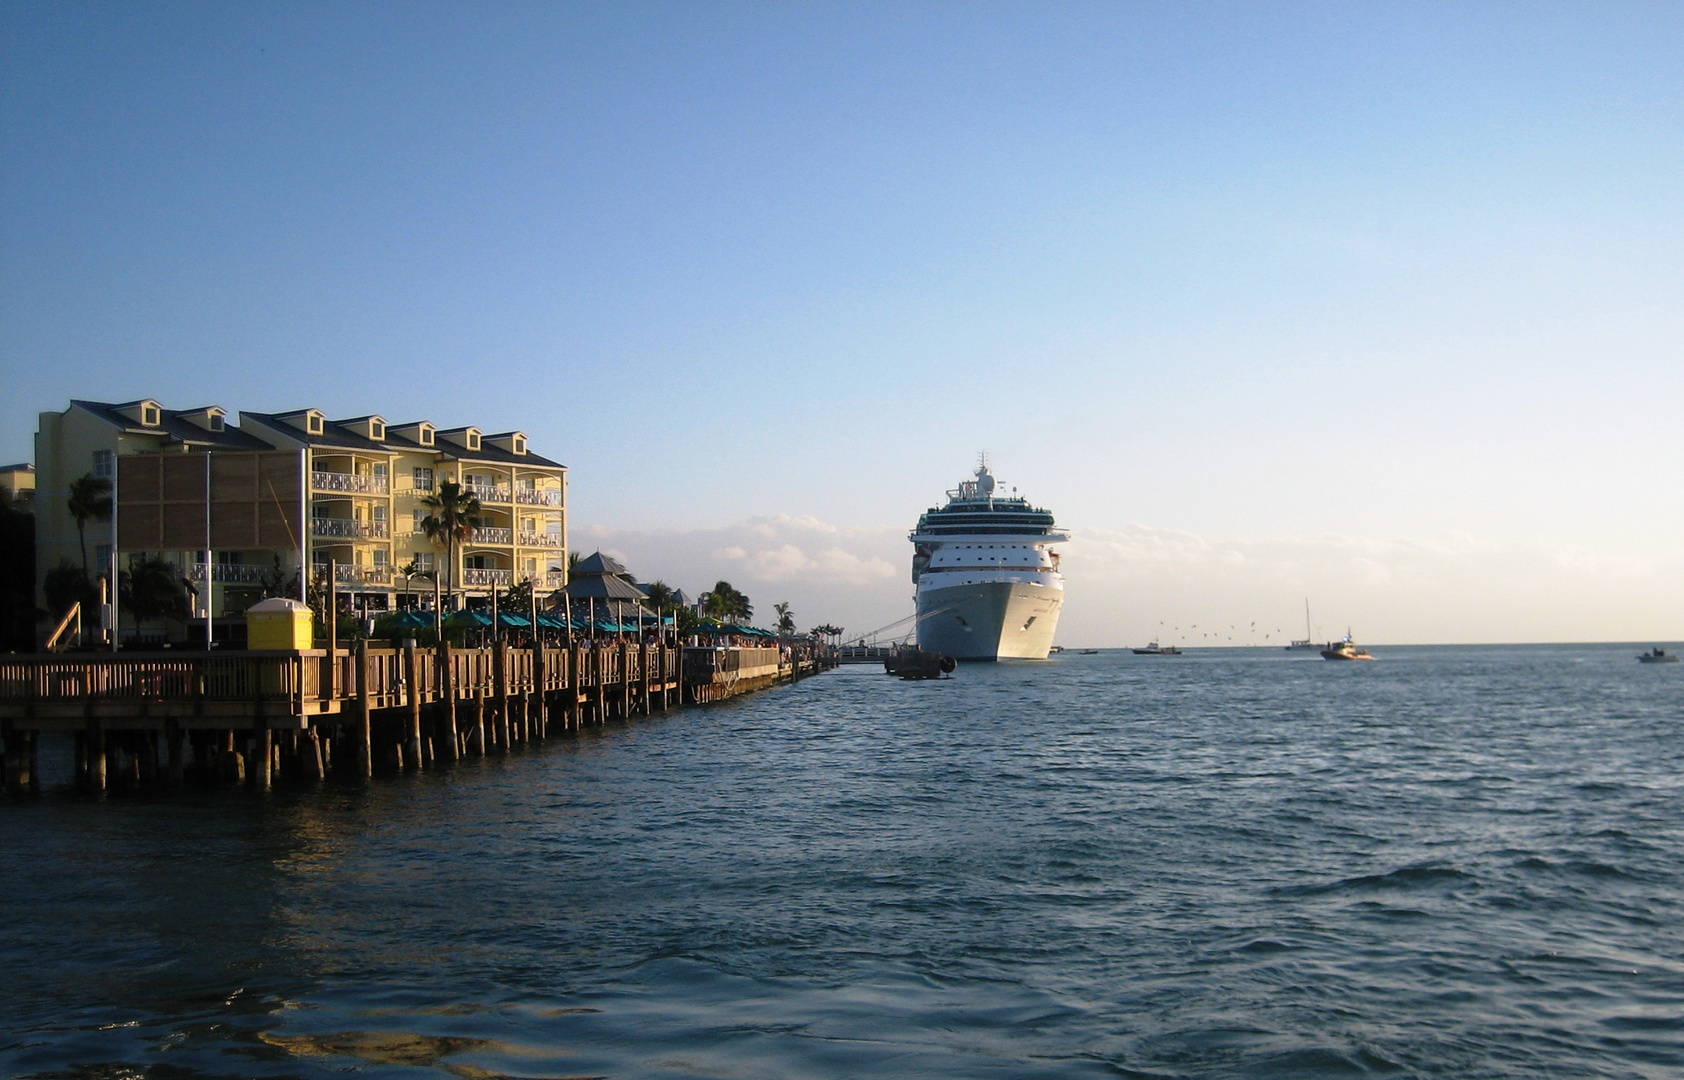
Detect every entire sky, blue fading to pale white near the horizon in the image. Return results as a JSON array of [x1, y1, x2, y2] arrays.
[[0, 3, 1684, 644]]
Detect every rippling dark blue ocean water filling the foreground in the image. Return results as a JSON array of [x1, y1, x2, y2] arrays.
[[0, 645, 1684, 1080]]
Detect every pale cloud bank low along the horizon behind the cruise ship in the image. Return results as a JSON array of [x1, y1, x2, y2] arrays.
[[574, 514, 1684, 645]]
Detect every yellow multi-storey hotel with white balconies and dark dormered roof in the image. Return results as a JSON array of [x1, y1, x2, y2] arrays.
[[35, 399, 568, 633]]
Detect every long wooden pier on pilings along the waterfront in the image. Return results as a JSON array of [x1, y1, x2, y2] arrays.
[[0, 640, 835, 792]]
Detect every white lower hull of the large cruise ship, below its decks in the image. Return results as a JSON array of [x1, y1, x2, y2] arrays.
[[918, 581, 1064, 660]]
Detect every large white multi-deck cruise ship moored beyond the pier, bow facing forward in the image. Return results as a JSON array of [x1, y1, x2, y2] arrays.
[[909, 460, 1069, 660]]
